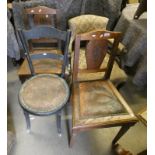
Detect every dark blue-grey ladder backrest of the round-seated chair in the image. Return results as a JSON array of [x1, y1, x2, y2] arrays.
[[19, 25, 70, 76]]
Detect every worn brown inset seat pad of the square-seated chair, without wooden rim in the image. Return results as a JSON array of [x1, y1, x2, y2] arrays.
[[77, 81, 125, 117]]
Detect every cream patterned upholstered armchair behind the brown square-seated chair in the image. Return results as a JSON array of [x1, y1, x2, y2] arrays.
[[68, 15, 127, 86]]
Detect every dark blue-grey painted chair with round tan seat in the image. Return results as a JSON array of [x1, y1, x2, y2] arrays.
[[19, 26, 70, 134]]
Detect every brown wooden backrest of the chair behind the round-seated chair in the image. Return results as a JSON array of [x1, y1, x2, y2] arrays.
[[24, 6, 61, 49]]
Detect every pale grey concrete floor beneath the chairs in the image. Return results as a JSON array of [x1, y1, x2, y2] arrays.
[[7, 59, 147, 155]]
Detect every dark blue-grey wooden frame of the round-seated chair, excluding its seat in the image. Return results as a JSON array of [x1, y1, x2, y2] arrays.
[[19, 26, 70, 134]]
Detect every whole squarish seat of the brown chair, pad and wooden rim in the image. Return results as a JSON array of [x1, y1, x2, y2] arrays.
[[72, 80, 137, 127]]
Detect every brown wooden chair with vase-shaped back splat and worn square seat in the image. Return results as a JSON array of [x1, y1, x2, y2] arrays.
[[70, 30, 137, 146]]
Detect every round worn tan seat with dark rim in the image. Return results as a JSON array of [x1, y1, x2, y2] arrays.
[[19, 74, 69, 115]]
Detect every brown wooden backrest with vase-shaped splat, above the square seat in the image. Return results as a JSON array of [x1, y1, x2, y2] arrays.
[[73, 30, 121, 82]]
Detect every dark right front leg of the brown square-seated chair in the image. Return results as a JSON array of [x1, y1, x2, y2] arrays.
[[112, 123, 135, 145]]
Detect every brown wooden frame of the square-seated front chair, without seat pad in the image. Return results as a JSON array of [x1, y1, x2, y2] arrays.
[[70, 30, 137, 147]]
